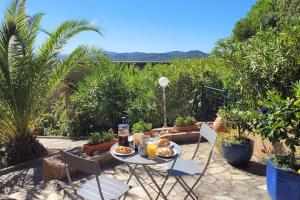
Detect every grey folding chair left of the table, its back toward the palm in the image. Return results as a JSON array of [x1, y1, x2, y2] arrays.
[[60, 151, 129, 200]]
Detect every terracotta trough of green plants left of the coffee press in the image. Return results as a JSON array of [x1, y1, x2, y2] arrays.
[[83, 129, 118, 155]]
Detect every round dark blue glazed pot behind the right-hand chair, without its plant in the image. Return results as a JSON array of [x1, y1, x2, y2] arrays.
[[222, 140, 253, 166]]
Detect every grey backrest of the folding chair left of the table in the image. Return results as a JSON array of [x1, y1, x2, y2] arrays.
[[60, 151, 101, 175]]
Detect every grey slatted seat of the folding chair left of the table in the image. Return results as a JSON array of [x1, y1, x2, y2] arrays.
[[76, 175, 129, 200]]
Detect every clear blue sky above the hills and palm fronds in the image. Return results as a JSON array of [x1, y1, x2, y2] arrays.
[[0, 0, 255, 53]]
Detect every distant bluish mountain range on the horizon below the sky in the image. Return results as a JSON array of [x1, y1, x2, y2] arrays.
[[105, 50, 208, 61]]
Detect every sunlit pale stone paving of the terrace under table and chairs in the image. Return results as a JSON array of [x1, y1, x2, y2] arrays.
[[0, 143, 269, 200]]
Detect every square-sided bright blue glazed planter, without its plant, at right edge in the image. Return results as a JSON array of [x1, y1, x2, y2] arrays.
[[267, 158, 300, 200]]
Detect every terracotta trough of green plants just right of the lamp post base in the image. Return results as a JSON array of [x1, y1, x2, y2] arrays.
[[173, 116, 199, 133]]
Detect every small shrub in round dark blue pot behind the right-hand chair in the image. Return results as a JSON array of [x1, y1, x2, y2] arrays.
[[219, 106, 253, 166]]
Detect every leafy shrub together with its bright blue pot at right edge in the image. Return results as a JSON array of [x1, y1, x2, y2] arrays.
[[254, 82, 300, 200]]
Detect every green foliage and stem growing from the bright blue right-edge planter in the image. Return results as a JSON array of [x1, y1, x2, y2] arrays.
[[254, 82, 300, 168]]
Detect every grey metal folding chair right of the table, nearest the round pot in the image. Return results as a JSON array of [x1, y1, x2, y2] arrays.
[[166, 124, 217, 199]]
